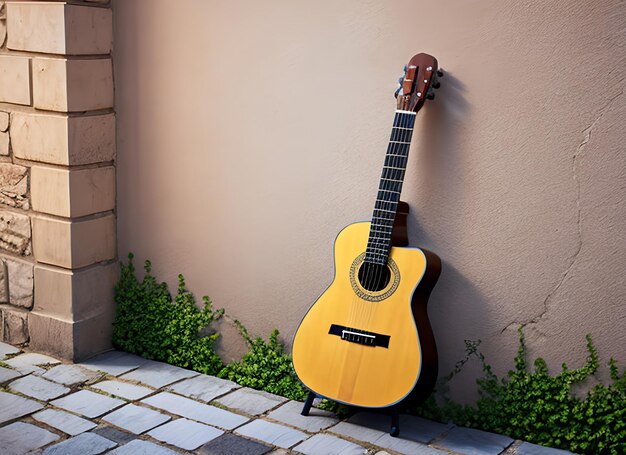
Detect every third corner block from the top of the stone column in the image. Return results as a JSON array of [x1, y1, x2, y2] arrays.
[[11, 112, 115, 166]]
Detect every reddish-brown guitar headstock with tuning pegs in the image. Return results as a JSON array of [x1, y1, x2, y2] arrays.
[[395, 53, 443, 112]]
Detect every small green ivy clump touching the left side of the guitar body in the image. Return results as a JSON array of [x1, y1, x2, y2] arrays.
[[219, 320, 307, 401]]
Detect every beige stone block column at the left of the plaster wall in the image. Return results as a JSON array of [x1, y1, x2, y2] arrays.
[[0, 0, 118, 361]]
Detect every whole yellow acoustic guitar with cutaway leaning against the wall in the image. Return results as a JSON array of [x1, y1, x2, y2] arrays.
[[292, 53, 443, 415]]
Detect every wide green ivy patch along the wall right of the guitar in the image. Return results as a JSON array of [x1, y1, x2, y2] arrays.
[[417, 329, 626, 455]]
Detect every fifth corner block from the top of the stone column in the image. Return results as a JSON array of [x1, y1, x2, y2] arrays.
[[32, 215, 115, 268]]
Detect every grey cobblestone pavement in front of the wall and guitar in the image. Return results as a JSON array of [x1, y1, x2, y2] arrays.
[[0, 343, 569, 455]]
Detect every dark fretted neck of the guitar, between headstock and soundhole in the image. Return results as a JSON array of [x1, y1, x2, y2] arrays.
[[365, 110, 416, 265]]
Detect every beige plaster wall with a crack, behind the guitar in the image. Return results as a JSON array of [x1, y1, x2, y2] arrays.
[[114, 0, 626, 399]]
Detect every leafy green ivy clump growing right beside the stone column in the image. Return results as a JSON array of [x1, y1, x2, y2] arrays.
[[113, 254, 224, 375]]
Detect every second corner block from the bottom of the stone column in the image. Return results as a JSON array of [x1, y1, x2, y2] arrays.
[[35, 263, 119, 322]]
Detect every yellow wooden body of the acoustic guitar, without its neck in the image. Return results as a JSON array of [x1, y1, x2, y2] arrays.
[[293, 222, 440, 408]]
